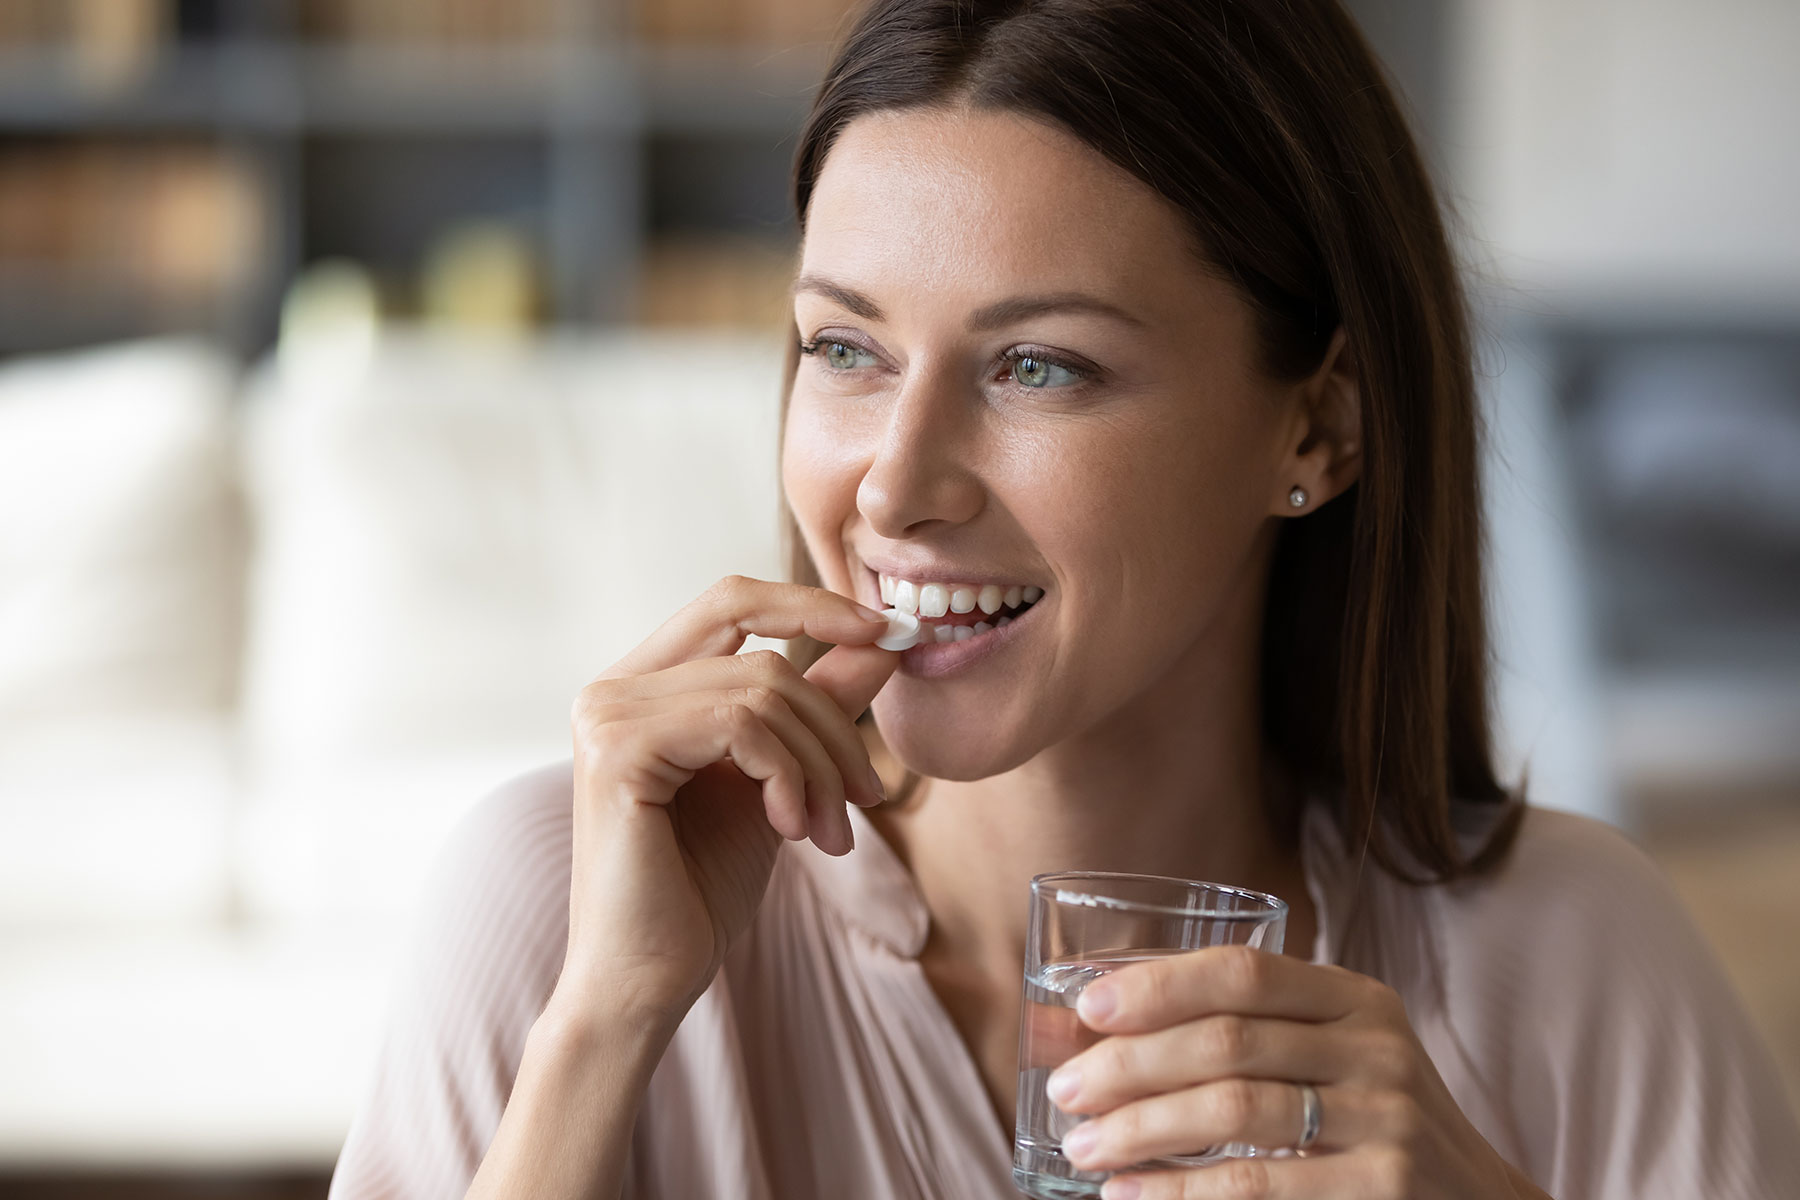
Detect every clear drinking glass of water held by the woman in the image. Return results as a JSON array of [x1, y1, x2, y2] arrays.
[[1013, 871, 1287, 1200]]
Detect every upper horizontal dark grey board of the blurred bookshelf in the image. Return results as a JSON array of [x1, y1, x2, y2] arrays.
[[0, 41, 823, 137]]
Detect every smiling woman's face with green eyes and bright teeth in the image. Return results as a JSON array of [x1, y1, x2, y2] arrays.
[[783, 110, 1339, 779]]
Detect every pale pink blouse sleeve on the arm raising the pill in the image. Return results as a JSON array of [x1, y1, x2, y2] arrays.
[[329, 763, 572, 1200]]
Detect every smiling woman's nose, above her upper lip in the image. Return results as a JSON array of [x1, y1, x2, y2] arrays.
[[857, 361, 986, 540]]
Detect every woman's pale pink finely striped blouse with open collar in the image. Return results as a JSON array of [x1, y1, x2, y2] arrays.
[[331, 763, 1800, 1200]]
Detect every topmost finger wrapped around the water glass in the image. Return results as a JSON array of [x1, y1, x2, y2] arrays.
[[1076, 946, 1370, 1033]]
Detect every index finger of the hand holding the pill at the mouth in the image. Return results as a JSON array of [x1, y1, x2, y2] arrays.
[[599, 576, 887, 678]]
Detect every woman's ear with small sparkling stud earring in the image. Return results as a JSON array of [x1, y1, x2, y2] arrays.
[[1271, 326, 1363, 516]]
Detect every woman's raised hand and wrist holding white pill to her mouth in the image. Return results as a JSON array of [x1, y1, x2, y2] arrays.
[[551, 576, 900, 1025]]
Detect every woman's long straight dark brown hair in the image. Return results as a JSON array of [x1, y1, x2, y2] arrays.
[[781, 0, 1523, 883]]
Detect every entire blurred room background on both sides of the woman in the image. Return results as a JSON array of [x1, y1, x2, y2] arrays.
[[0, 0, 1800, 1198]]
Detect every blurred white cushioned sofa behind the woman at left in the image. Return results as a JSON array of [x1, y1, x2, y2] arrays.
[[0, 331, 781, 1166]]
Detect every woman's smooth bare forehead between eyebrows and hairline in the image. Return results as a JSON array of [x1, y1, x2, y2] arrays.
[[801, 108, 1201, 299]]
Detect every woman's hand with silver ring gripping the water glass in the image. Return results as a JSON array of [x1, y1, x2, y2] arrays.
[[1048, 946, 1548, 1200]]
